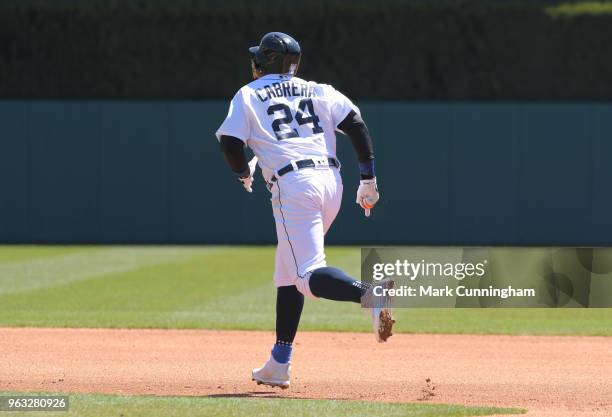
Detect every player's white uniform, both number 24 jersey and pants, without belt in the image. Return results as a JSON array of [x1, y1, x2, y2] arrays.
[[216, 74, 359, 297]]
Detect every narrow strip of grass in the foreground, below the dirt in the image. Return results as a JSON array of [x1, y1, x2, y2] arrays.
[[2, 394, 523, 417]]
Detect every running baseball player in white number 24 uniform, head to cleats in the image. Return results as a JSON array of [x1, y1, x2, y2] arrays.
[[216, 32, 394, 388]]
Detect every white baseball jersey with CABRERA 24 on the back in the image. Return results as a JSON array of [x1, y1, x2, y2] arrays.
[[216, 74, 359, 178]]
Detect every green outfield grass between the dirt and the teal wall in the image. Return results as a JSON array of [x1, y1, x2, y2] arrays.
[[0, 246, 612, 335]]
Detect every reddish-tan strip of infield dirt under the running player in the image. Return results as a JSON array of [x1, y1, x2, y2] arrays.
[[0, 328, 612, 417]]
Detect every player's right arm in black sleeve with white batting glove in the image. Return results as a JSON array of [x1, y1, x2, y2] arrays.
[[338, 110, 380, 216]]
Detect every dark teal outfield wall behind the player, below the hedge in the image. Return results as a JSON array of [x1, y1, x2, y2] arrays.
[[0, 101, 612, 245]]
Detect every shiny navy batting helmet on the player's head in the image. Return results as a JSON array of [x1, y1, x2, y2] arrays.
[[249, 32, 302, 75]]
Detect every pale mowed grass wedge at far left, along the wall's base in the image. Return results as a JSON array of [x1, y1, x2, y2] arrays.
[[0, 247, 211, 294]]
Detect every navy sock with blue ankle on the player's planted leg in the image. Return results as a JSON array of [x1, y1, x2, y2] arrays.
[[272, 285, 304, 363]]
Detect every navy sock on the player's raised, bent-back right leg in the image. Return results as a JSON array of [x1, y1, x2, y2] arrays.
[[310, 266, 367, 303]]
